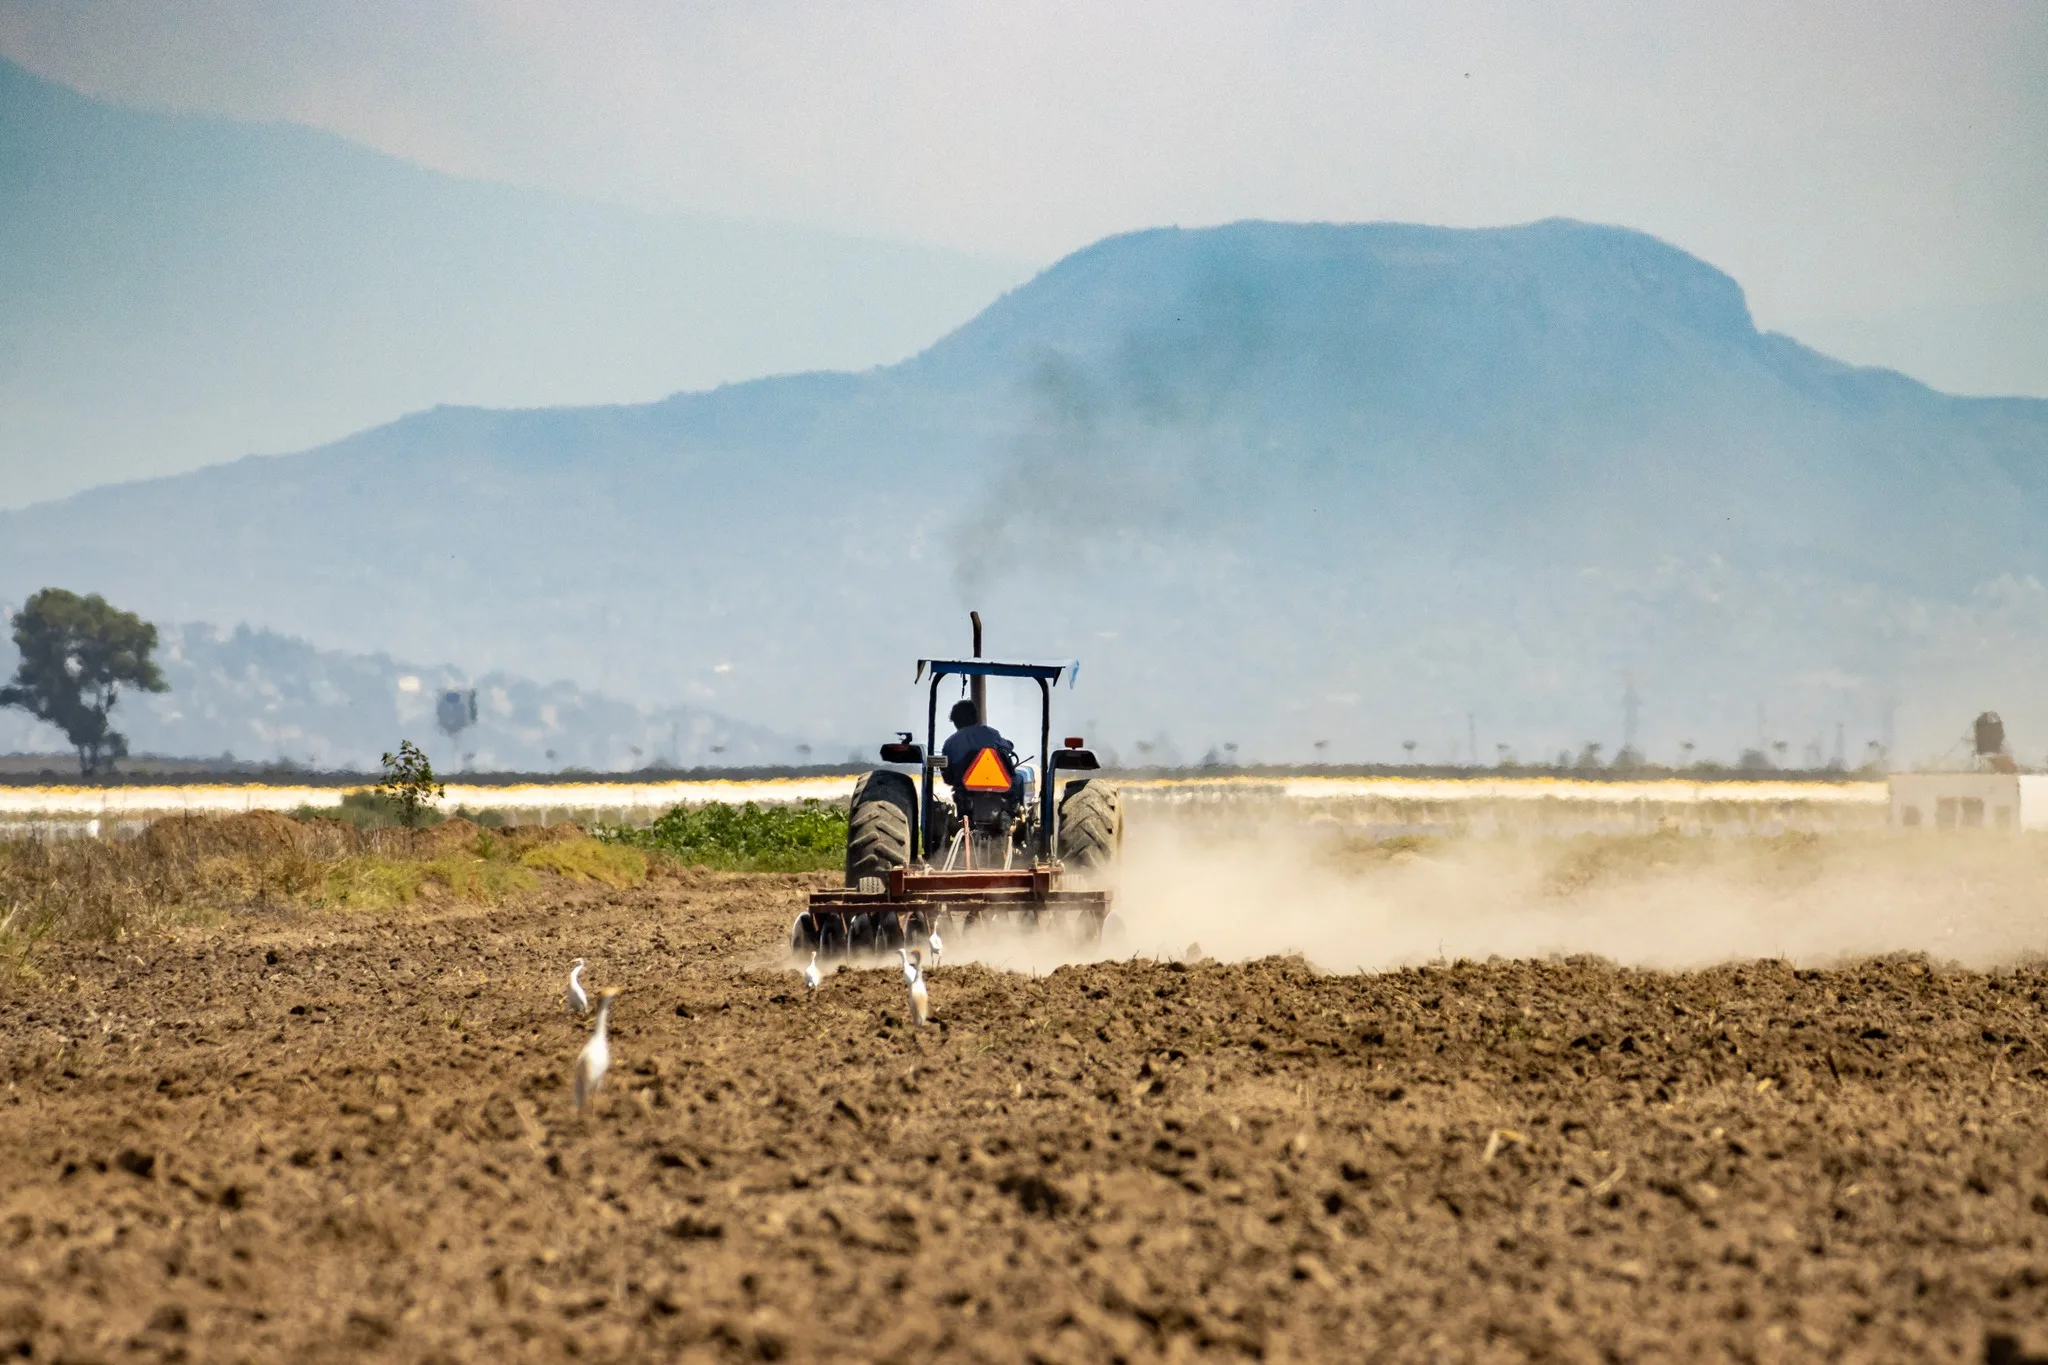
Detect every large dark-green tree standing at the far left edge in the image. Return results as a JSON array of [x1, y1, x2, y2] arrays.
[[0, 587, 170, 778]]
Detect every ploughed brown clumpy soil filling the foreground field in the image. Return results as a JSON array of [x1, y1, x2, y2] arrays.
[[0, 874, 2048, 1361]]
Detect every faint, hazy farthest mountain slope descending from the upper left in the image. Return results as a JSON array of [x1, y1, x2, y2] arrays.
[[0, 61, 1024, 505]]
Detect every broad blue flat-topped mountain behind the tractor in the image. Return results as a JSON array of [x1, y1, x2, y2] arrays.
[[0, 221, 2048, 761]]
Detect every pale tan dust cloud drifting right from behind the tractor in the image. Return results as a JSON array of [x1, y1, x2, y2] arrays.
[[948, 821, 2048, 972]]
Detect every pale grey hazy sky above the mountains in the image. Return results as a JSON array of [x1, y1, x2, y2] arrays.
[[0, 0, 2048, 393]]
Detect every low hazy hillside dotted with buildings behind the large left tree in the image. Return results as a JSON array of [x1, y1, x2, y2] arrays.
[[0, 624, 815, 774]]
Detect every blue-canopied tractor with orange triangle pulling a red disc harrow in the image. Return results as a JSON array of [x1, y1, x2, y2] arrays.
[[788, 614, 1124, 958]]
